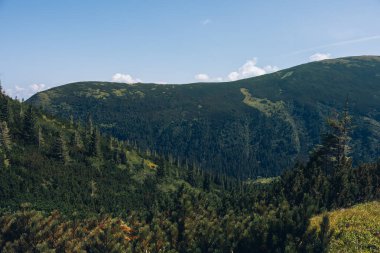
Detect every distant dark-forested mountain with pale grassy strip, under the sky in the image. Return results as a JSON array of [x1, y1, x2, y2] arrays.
[[27, 56, 380, 177]]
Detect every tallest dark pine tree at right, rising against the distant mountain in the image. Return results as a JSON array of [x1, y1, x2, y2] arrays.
[[303, 101, 354, 207]]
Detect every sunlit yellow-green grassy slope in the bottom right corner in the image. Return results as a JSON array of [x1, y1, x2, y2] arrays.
[[311, 201, 380, 253]]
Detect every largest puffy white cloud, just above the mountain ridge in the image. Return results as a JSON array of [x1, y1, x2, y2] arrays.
[[227, 58, 279, 81]]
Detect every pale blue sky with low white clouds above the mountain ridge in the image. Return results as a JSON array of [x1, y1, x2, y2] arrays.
[[0, 0, 380, 98]]
